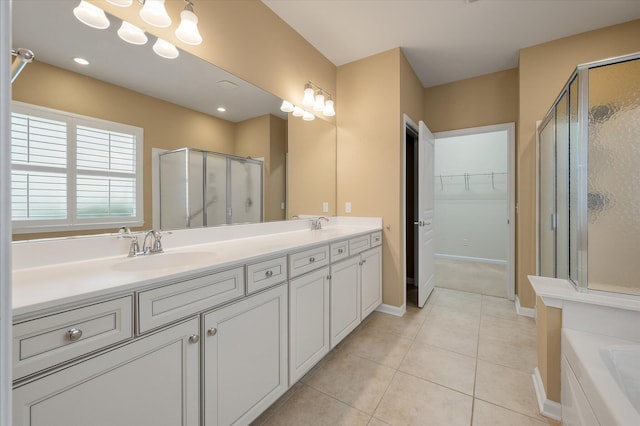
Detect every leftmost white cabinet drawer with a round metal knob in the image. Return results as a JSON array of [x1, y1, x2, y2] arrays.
[[13, 296, 133, 379]]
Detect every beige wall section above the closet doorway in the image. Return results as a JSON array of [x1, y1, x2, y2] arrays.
[[422, 68, 518, 132]]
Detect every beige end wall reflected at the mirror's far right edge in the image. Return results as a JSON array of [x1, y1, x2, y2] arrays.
[[287, 114, 336, 218]]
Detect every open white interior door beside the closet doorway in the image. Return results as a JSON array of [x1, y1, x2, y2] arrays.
[[414, 121, 435, 307]]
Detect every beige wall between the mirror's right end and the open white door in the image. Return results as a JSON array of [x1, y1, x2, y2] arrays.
[[338, 49, 404, 306]]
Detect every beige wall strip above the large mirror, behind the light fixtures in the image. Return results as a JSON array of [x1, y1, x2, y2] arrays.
[[94, 0, 340, 116]]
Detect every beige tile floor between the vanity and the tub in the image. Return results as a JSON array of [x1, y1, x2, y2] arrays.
[[254, 288, 558, 426]]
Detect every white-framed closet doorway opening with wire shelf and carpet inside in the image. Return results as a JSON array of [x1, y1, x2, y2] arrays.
[[434, 123, 515, 300]]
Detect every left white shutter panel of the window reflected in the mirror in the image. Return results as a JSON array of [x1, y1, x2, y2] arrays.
[[11, 113, 67, 220]]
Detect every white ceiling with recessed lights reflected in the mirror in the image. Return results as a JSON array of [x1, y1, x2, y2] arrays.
[[12, 0, 287, 122]]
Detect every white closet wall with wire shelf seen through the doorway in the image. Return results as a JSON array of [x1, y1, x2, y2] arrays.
[[434, 130, 508, 262]]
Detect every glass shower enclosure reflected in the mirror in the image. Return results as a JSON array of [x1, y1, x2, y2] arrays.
[[159, 148, 264, 229]]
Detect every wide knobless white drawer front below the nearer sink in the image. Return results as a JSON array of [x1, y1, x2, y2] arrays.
[[138, 266, 244, 333]]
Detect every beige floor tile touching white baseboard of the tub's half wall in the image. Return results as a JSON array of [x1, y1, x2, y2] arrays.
[[475, 360, 544, 420]]
